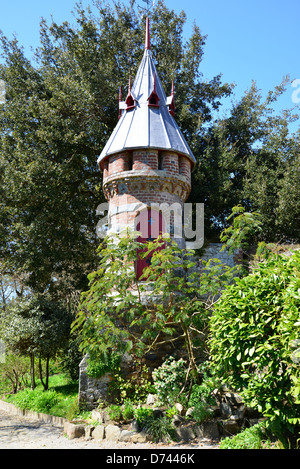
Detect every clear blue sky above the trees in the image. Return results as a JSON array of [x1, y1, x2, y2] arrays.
[[0, 0, 300, 131]]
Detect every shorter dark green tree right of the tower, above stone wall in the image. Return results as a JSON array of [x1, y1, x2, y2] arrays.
[[190, 77, 299, 242]]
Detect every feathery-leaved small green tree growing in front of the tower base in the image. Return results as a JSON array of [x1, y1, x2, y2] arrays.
[[73, 232, 237, 384]]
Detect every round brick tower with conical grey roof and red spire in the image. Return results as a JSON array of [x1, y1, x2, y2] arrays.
[[98, 18, 196, 274]]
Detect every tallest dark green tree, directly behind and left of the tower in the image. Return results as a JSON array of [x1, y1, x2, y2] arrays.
[[0, 1, 231, 298]]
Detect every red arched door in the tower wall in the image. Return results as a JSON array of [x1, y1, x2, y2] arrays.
[[136, 208, 165, 280]]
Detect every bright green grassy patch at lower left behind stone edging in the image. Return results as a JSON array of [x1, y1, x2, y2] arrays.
[[5, 374, 84, 420]]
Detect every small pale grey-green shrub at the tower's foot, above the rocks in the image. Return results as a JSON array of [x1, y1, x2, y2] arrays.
[[152, 356, 187, 404]]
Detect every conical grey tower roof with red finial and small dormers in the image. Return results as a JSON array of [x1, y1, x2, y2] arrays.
[[98, 19, 196, 168]]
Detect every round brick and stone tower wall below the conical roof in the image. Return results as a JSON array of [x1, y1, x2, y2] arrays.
[[100, 149, 191, 235]]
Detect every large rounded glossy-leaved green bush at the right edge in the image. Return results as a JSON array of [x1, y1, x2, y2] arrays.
[[210, 251, 300, 441]]
